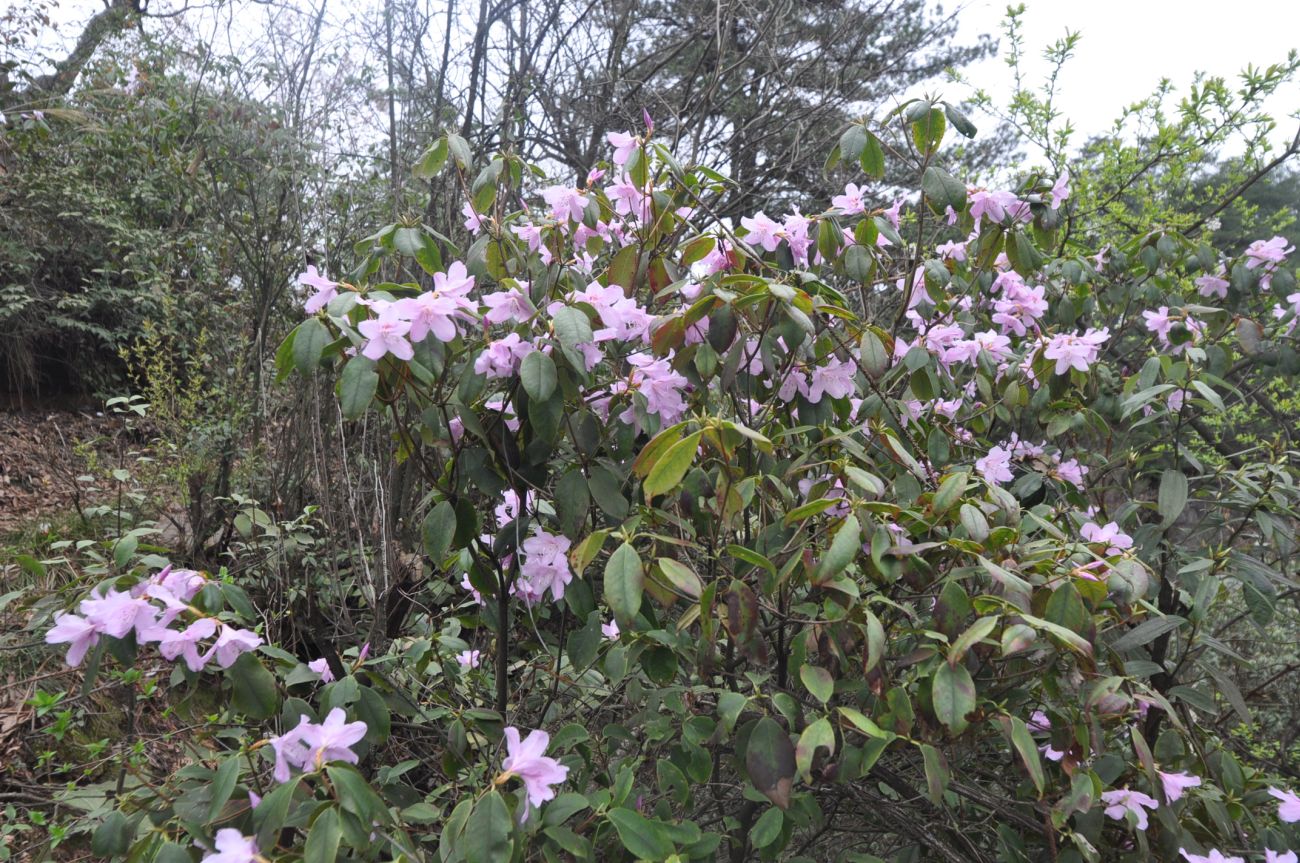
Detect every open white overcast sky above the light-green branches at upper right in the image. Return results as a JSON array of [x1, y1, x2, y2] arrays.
[[945, 0, 1300, 153]]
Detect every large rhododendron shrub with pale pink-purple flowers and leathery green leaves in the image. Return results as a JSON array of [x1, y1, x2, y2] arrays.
[[49, 101, 1300, 863]]
